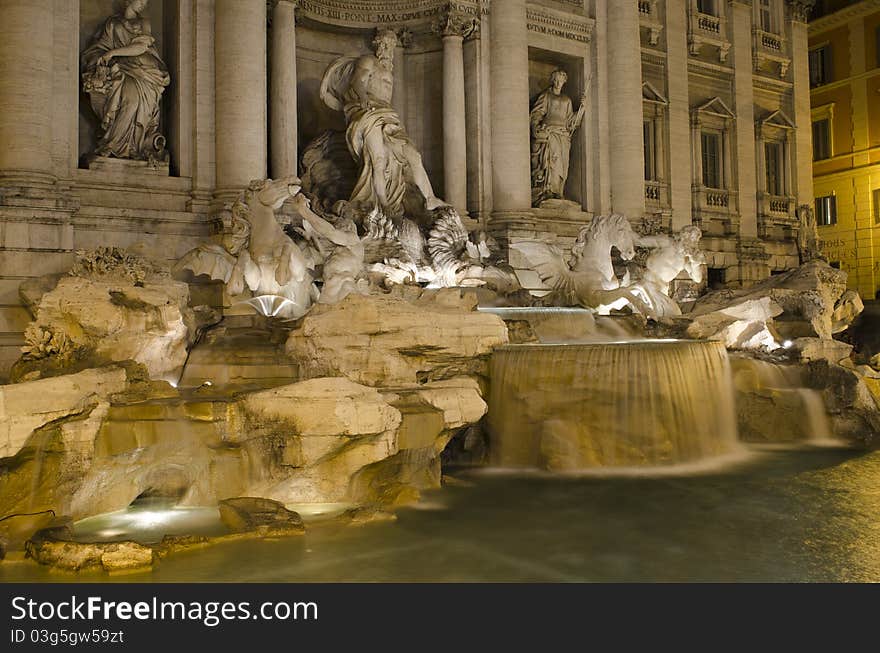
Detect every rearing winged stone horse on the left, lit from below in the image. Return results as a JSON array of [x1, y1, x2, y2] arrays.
[[177, 177, 317, 319]]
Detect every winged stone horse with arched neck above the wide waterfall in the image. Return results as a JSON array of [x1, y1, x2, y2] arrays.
[[510, 215, 651, 315]]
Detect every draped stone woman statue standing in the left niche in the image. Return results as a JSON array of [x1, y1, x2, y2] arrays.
[[82, 0, 171, 165]]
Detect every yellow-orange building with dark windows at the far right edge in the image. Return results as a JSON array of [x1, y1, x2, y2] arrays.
[[809, 0, 880, 298]]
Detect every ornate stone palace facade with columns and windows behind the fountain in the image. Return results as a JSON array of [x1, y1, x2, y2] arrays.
[[0, 0, 813, 378]]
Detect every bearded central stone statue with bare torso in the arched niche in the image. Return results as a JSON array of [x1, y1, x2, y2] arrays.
[[320, 29, 445, 218]]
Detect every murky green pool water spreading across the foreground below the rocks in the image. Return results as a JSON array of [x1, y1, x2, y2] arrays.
[[0, 448, 880, 582]]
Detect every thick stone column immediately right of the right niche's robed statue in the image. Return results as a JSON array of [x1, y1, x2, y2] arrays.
[[607, 0, 645, 220]]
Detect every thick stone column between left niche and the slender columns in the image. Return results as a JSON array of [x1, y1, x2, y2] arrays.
[[214, 0, 267, 202]]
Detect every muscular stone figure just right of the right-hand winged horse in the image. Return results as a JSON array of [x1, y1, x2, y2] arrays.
[[631, 226, 706, 319]]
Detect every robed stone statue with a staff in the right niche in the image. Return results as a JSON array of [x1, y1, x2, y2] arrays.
[[530, 69, 589, 206]]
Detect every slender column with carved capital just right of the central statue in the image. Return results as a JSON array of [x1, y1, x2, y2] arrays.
[[438, 9, 474, 215]]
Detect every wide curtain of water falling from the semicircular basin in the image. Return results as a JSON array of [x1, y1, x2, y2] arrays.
[[489, 340, 737, 471]]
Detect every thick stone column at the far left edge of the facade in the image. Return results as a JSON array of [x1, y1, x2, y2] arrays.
[[0, 0, 55, 186]]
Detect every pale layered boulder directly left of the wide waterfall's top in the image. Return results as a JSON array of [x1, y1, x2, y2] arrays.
[[286, 289, 507, 387]]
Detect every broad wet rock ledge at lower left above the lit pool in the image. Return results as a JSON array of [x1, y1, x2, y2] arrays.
[[0, 368, 486, 520]]
